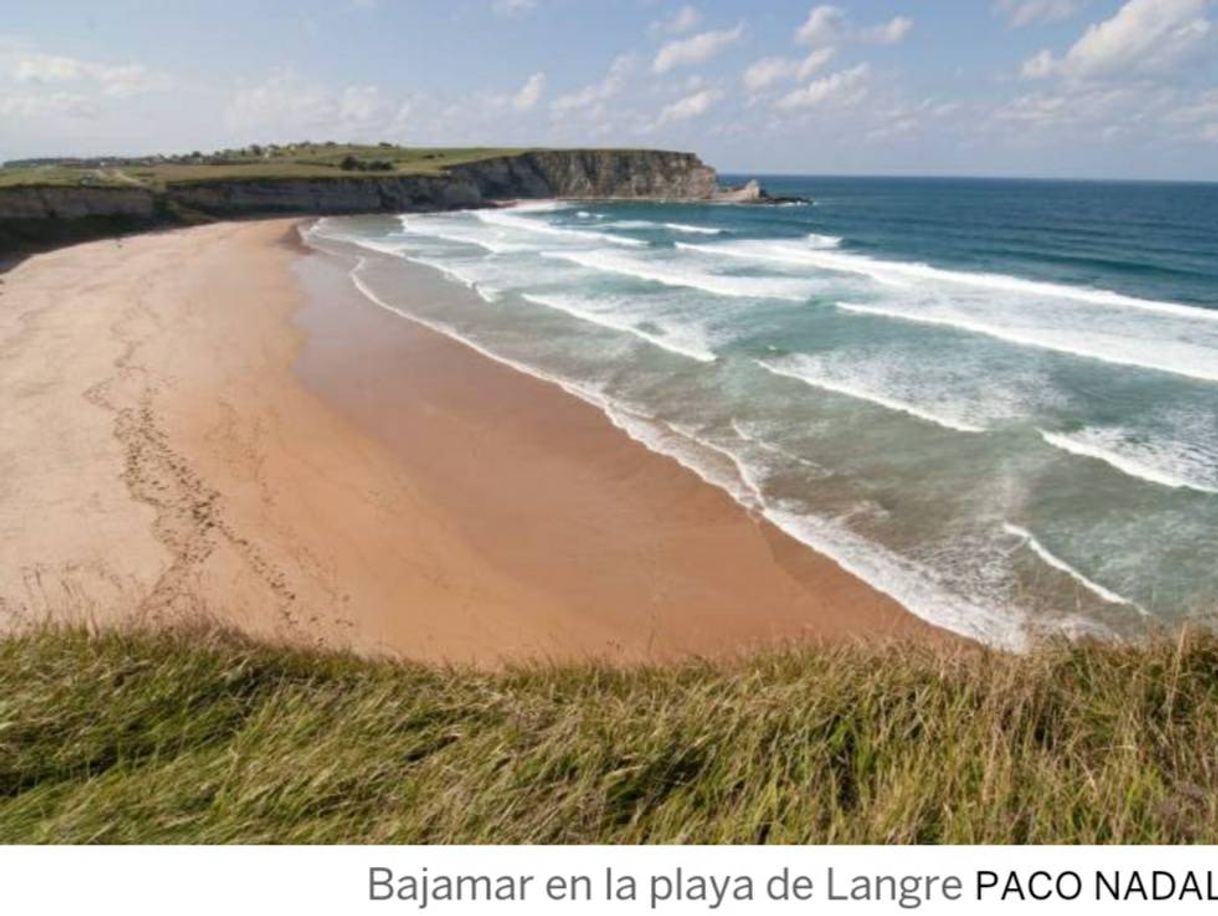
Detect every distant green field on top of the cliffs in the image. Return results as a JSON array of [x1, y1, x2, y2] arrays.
[[0, 144, 524, 190]]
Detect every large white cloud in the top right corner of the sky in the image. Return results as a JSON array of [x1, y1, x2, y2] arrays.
[[1022, 0, 1216, 79]]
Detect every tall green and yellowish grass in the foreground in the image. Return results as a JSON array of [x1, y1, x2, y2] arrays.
[[0, 630, 1218, 843]]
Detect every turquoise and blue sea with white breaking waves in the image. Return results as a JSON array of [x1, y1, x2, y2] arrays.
[[308, 177, 1218, 647]]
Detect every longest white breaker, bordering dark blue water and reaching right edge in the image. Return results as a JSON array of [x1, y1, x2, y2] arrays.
[[688, 236, 1218, 322]]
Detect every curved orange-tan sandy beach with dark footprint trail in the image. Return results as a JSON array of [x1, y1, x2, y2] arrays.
[[0, 219, 942, 665]]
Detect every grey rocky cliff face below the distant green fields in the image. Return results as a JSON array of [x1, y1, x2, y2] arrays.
[[0, 150, 717, 251]]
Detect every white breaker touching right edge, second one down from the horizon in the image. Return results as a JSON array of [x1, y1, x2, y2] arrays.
[[837, 302, 1218, 381]]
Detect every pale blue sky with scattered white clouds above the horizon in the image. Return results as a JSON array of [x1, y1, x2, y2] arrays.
[[0, 0, 1218, 180]]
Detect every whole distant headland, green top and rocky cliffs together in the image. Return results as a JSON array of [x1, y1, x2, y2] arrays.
[[0, 144, 721, 253]]
